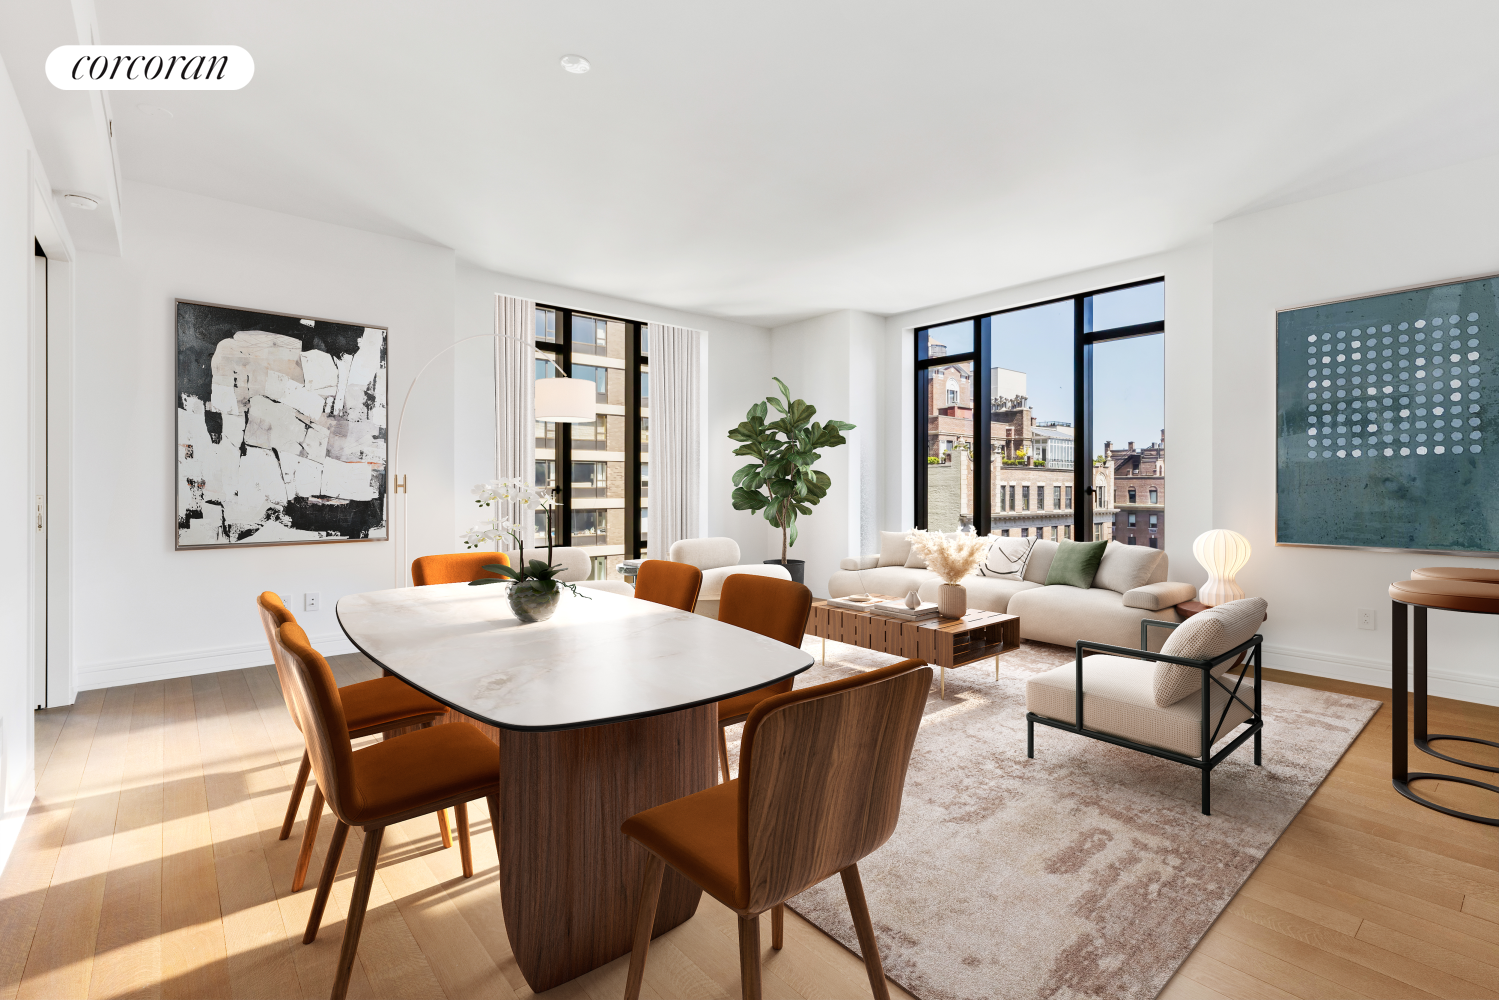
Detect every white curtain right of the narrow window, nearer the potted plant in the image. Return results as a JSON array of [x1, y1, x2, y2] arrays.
[[646, 322, 703, 559]]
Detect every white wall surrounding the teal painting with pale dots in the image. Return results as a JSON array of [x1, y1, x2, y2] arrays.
[[1211, 159, 1499, 705]]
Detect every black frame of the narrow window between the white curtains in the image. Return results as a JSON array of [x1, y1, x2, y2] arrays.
[[532, 301, 649, 559]]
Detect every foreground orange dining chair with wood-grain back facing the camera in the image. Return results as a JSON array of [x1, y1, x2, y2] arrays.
[[621, 659, 932, 1000]]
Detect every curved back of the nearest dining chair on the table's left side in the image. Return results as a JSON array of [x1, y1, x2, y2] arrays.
[[276, 622, 358, 823]]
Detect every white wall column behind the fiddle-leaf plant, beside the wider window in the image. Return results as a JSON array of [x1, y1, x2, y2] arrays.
[[760, 309, 886, 597]]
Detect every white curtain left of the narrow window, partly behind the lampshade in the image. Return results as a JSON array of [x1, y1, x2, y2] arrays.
[[495, 295, 537, 530]]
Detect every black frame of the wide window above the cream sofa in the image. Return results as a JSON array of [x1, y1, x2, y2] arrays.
[[911, 274, 1166, 541]]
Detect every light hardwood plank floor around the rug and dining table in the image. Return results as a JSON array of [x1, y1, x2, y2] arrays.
[[0, 657, 1499, 1000]]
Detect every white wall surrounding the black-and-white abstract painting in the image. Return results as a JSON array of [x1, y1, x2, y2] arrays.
[[71, 182, 454, 690]]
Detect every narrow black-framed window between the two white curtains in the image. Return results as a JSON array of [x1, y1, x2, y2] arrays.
[[532, 306, 649, 580]]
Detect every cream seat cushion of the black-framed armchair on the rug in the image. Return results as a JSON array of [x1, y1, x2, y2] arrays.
[[1025, 653, 1250, 757]]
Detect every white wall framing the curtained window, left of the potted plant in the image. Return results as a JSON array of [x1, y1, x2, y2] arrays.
[[449, 262, 776, 562]]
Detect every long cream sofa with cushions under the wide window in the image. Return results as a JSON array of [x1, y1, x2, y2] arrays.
[[827, 532, 1196, 648]]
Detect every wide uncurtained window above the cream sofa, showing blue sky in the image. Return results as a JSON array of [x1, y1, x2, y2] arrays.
[[916, 279, 1166, 547]]
